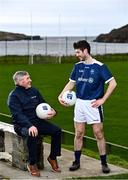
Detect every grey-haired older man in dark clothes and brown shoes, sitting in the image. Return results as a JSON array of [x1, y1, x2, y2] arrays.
[[8, 71, 61, 177]]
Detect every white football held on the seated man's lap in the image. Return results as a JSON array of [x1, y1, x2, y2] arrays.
[[36, 103, 51, 119]]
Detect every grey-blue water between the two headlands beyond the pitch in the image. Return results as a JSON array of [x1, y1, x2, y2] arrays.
[[0, 37, 128, 56]]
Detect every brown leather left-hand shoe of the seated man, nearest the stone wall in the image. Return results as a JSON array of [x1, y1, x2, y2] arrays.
[[27, 164, 40, 177]]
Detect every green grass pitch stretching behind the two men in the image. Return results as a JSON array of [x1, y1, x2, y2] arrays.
[[0, 62, 128, 146]]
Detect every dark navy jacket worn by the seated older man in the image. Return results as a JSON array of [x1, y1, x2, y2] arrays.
[[8, 86, 46, 134]]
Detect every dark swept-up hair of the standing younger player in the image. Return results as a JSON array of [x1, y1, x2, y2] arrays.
[[73, 40, 91, 54]]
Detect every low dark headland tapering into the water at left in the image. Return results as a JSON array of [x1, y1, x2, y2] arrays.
[[0, 31, 41, 41]]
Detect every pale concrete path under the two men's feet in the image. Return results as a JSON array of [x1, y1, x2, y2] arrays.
[[0, 143, 128, 180]]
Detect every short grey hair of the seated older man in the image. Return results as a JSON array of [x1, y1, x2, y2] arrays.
[[13, 71, 28, 85]]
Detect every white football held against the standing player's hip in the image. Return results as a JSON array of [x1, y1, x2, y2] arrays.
[[62, 91, 76, 106]]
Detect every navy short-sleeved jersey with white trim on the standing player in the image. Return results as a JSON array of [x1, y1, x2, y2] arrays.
[[69, 59, 113, 100]]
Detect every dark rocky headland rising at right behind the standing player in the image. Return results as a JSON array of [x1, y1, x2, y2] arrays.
[[94, 24, 128, 43]]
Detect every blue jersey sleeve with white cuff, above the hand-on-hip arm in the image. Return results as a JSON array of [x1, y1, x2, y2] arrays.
[[101, 64, 114, 84]]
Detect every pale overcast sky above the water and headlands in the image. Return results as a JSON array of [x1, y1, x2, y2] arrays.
[[0, 0, 128, 37]]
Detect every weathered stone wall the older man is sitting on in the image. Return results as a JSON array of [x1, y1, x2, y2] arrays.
[[0, 122, 44, 170]]
